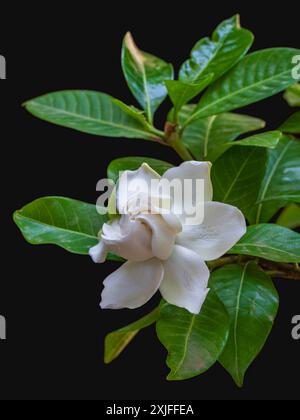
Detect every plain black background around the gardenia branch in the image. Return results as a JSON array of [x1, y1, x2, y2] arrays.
[[0, 1, 300, 400]]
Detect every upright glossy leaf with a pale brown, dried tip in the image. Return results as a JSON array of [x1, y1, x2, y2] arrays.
[[122, 33, 174, 123]]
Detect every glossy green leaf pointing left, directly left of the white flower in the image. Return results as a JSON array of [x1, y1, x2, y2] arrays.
[[14, 197, 107, 255]]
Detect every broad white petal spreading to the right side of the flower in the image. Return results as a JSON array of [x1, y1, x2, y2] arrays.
[[176, 202, 247, 261]]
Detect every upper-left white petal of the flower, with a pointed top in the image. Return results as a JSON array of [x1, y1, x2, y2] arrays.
[[117, 163, 161, 214]]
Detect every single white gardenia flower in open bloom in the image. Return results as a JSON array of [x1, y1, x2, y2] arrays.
[[90, 161, 246, 314]]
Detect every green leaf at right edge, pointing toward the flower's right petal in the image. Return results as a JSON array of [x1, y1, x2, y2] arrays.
[[229, 224, 300, 263]]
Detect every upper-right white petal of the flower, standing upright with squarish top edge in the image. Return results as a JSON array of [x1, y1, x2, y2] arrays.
[[162, 161, 213, 215]]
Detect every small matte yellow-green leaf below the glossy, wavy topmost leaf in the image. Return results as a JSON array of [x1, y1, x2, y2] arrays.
[[165, 74, 213, 120]]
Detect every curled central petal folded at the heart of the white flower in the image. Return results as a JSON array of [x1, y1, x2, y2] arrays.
[[137, 214, 177, 260]]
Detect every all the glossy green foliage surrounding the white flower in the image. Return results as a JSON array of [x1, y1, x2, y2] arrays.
[[14, 16, 300, 386]]
